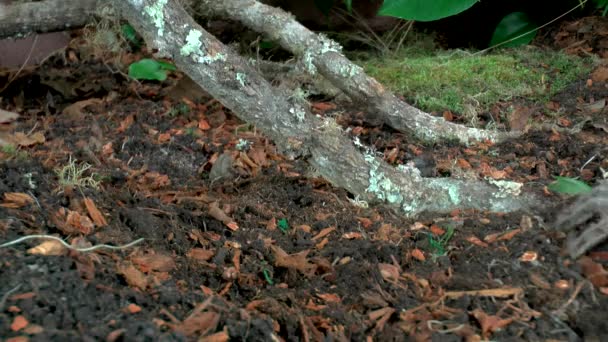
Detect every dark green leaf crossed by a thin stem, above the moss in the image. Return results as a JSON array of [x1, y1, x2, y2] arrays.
[[490, 12, 538, 47]]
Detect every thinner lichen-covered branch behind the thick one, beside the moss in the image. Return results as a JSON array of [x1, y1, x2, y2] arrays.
[[199, 0, 519, 144]]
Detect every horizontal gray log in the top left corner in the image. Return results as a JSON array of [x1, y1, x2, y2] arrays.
[[0, 0, 101, 38]]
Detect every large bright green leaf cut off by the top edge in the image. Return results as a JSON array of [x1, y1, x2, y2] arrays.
[[378, 0, 478, 21]]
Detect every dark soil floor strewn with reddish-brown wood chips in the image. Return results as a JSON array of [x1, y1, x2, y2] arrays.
[[0, 14, 608, 341]]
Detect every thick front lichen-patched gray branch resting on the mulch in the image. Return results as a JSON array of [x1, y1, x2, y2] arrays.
[[114, 0, 535, 215]]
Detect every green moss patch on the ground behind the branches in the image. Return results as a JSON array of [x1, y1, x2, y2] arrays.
[[358, 47, 594, 116]]
